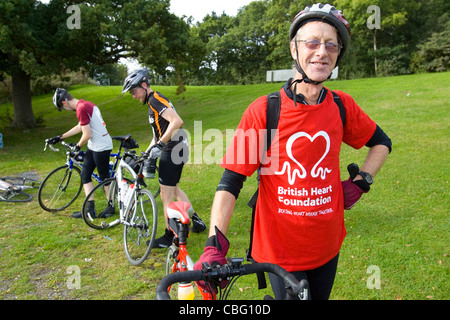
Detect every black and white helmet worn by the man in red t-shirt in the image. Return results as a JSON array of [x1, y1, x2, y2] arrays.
[[289, 3, 351, 84]]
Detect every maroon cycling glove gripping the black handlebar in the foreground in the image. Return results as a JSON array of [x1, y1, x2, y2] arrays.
[[194, 227, 230, 294]]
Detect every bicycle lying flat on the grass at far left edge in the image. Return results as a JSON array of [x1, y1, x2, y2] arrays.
[[0, 177, 41, 202]]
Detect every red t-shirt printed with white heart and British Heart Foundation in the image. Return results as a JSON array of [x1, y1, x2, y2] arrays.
[[222, 89, 376, 271]]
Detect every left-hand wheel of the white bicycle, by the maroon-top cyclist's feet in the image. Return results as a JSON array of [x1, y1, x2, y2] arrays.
[[82, 178, 120, 230]]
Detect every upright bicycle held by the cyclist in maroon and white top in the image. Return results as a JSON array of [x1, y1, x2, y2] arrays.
[[38, 135, 153, 212]]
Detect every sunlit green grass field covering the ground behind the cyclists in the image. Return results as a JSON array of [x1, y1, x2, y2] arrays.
[[0, 73, 450, 300]]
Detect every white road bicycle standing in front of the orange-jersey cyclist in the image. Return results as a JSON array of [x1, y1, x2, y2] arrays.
[[82, 153, 157, 265]]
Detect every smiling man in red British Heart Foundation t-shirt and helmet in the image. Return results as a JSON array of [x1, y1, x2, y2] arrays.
[[195, 4, 391, 299]]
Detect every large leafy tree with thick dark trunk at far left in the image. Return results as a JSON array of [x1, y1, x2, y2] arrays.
[[0, 0, 189, 128]]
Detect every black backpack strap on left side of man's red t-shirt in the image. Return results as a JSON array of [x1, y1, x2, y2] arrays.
[[246, 91, 281, 289]]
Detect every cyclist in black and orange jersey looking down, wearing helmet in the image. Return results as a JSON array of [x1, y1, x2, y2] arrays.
[[122, 68, 206, 248]]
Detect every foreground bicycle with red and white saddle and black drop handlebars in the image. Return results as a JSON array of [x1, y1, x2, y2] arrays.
[[156, 201, 309, 300]]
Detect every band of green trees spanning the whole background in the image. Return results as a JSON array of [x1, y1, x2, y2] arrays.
[[0, 0, 450, 126]]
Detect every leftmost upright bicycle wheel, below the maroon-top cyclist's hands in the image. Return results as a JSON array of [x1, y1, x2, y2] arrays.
[[38, 164, 83, 212]]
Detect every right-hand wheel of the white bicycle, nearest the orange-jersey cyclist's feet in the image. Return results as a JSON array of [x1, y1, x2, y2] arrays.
[[123, 190, 158, 266]]
